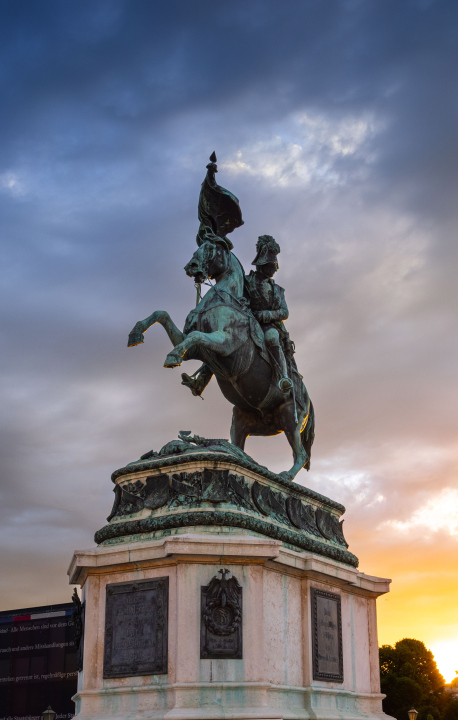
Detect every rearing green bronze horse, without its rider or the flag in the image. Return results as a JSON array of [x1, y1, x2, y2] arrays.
[[128, 238, 315, 480]]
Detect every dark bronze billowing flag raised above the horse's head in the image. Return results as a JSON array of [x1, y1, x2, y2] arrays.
[[196, 152, 243, 250]]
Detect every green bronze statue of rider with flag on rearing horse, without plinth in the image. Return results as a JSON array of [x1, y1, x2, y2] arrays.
[[128, 153, 315, 480]]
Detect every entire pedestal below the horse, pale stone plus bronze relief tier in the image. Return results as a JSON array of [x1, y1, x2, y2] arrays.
[[69, 444, 389, 720]]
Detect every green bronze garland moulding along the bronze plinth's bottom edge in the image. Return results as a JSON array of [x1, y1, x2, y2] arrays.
[[94, 510, 358, 567]]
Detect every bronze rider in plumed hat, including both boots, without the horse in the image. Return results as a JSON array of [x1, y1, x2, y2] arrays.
[[181, 235, 293, 398]]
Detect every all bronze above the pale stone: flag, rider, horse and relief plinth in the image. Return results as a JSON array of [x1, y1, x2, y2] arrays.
[[113, 153, 358, 567]]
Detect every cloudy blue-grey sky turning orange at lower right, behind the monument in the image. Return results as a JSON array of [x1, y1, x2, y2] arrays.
[[0, 0, 458, 679]]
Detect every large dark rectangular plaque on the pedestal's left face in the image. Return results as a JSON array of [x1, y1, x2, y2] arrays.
[[103, 577, 169, 678]]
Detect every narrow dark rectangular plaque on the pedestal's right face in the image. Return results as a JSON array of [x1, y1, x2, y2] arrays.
[[311, 588, 343, 682]]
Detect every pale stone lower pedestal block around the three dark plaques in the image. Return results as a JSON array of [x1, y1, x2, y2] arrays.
[[69, 527, 390, 720]]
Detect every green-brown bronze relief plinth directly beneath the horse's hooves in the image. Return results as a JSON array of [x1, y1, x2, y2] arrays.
[[96, 431, 357, 566]]
